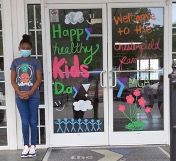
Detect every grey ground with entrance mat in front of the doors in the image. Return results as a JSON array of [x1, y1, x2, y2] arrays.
[[0, 146, 170, 161]]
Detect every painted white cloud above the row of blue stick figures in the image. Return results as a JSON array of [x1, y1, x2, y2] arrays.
[[73, 100, 93, 111]]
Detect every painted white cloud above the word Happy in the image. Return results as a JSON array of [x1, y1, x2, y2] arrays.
[[65, 11, 84, 25]]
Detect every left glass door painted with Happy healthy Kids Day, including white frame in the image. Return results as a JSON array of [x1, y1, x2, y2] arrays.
[[46, 4, 108, 146]]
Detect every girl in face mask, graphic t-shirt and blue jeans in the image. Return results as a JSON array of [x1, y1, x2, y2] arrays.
[[10, 34, 42, 157]]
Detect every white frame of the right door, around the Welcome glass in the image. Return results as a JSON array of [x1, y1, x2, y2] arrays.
[[108, 2, 171, 145]]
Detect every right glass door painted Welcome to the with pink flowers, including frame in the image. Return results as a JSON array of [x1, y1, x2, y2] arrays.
[[108, 3, 169, 145]]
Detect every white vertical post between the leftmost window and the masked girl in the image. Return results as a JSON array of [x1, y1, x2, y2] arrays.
[[0, 0, 17, 150]]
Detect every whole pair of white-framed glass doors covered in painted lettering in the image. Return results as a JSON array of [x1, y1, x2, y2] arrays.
[[46, 3, 169, 146]]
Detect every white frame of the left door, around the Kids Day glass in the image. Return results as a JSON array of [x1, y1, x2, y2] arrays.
[[45, 4, 108, 147]]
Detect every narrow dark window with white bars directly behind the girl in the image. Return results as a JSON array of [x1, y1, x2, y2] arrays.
[[26, 4, 46, 144]]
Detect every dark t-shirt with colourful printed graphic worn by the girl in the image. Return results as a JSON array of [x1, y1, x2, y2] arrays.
[[10, 57, 42, 98]]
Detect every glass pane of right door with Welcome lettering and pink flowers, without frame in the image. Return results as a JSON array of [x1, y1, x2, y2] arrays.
[[112, 8, 164, 131]]
